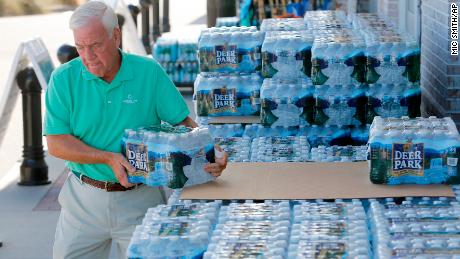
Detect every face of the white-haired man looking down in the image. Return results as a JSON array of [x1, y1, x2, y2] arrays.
[[73, 20, 120, 77]]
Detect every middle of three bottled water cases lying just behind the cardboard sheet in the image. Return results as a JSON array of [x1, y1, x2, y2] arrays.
[[251, 136, 310, 162]]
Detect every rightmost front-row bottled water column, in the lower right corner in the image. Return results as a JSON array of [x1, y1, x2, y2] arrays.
[[369, 197, 460, 259]]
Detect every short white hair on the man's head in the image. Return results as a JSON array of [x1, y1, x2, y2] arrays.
[[69, 1, 118, 38]]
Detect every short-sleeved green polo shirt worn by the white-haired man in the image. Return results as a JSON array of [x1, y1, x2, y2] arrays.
[[44, 52, 189, 182]]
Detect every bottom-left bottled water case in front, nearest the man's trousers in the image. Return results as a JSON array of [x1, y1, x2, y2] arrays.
[[127, 218, 212, 258]]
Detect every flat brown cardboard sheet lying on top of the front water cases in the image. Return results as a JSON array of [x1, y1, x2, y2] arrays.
[[181, 162, 454, 200]]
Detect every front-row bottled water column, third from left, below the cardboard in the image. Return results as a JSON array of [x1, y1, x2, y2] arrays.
[[288, 200, 371, 258]]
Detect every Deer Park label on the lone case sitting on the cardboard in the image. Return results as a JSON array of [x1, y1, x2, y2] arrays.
[[391, 142, 424, 177]]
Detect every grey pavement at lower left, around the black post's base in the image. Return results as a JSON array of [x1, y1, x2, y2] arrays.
[[0, 156, 67, 259]]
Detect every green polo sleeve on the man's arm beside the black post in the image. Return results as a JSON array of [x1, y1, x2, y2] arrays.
[[43, 73, 72, 135]]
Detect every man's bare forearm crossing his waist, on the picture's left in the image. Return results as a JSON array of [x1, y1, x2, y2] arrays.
[[46, 134, 112, 164]]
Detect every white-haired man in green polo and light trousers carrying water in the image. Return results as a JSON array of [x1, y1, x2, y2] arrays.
[[44, 1, 227, 259]]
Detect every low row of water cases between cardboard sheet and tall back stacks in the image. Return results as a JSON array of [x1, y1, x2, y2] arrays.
[[208, 124, 369, 162]]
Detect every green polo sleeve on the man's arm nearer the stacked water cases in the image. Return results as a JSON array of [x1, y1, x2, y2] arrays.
[[155, 65, 190, 125]]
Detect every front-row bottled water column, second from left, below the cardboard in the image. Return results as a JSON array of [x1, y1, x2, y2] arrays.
[[203, 201, 291, 259]]
